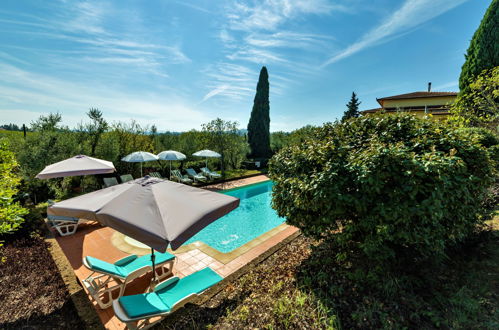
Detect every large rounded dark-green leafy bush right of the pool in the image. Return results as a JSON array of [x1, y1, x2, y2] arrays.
[[269, 114, 499, 266]]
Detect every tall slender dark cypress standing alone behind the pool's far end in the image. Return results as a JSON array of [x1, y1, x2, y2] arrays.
[[248, 67, 272, 158]]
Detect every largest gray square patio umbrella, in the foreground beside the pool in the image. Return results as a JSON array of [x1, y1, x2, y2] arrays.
[[47, 176, 239, 278]]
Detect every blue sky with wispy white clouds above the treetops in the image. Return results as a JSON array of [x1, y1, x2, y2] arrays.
[[0, 0, 490, 131]]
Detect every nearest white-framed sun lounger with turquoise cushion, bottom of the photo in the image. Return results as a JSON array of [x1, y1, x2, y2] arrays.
[[113, 267, 222, 329]]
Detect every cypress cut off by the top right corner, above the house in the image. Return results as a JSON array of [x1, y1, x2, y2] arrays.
[[459, 0, 499, 94]]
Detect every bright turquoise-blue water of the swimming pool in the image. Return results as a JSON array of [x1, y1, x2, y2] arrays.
[[185, 181, 285, 253]]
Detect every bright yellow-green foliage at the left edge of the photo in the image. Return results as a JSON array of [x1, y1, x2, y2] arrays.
[[0, 139, 27, 253]]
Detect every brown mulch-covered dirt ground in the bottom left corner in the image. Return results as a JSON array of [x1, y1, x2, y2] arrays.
[[0, 237, 84, 330]]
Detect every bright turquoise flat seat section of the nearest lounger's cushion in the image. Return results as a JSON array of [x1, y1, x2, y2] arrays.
[[157, 267, 223, 307]]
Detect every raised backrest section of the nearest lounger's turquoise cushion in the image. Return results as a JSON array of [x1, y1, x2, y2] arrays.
[[119, 292, 170, 318]]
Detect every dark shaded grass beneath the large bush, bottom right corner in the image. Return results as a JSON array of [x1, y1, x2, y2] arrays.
[[296, 228, 499, 329]]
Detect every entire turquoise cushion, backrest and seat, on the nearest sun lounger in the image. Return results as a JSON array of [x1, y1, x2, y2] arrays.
[[119, 268, 222, 319]]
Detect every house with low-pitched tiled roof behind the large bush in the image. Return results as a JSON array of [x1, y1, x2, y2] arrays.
[[360, 83, 457, 120]]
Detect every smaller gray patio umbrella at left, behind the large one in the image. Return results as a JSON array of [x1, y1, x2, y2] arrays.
[[36, 155, 116, 179]]
